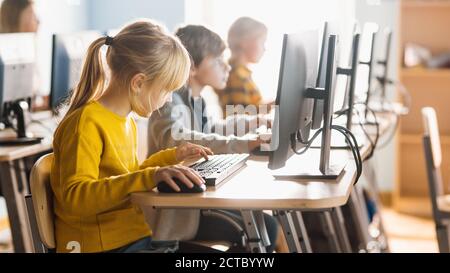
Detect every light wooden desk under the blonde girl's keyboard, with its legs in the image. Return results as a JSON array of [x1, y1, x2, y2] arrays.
[[131, 150, 356, 253]]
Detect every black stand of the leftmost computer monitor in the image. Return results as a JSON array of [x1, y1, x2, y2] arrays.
[[0, 100, 43, 146]]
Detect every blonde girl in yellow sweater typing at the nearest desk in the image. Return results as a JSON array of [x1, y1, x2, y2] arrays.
[[51, 21, 212, 252]]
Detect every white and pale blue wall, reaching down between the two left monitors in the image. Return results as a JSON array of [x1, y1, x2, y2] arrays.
[[32, 0, 184, 95]]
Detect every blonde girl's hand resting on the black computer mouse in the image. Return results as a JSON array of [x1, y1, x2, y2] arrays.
[[153, 165, 205, 192]]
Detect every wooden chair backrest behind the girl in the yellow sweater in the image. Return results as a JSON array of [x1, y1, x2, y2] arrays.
[[30, 154, 56, 249]]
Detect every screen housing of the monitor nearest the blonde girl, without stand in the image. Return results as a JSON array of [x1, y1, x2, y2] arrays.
[[269, 30, 318, 170]]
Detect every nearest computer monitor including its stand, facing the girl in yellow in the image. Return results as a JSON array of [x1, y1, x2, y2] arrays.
[[269, 31, 344, 179]]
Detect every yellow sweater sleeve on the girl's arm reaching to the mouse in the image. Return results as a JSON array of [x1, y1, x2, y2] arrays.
[[58, 122, 157, 217]]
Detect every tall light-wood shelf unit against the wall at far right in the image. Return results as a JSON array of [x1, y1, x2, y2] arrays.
[[393, 0, 450, 216]]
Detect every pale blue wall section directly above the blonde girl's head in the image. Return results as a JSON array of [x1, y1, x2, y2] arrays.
[[88, 0, 185, 30]]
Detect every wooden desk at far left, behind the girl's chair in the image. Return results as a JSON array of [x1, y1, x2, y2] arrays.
[[0, 112, 52, 253]]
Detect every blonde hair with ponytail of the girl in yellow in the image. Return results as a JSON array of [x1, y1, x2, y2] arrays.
[[59, 20, 190, 124]]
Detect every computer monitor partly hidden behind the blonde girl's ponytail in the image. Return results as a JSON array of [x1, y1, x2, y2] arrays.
[[50, 31, 101, 111]]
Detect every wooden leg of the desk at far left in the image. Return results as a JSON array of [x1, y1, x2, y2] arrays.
[[0, 162, 33, 253]]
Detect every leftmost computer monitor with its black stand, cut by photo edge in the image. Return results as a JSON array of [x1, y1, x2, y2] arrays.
[[0, 33, 41, 146]]
